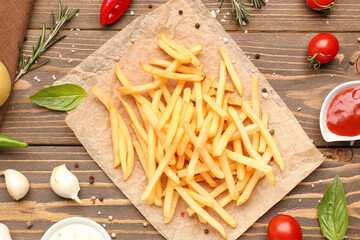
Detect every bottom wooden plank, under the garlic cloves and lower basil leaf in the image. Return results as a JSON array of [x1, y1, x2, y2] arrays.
[[0, 146, 360, 240]]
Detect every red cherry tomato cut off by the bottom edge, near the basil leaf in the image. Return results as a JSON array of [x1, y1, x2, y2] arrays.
[[268, 215, 302, 240]]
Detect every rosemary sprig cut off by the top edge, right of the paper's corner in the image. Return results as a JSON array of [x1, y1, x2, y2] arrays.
[[219, 0, 266, 26]]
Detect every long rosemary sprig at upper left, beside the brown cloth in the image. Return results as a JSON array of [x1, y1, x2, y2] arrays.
[[15, 0, 79, 82]]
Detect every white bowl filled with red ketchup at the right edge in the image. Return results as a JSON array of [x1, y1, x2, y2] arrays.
[[320, 80, 360, 142]]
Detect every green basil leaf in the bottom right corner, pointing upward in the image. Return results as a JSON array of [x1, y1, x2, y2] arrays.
[[318, 175, 348, 240]]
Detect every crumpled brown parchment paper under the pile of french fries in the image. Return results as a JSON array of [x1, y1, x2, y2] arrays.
[[56, 0, 323, 240]]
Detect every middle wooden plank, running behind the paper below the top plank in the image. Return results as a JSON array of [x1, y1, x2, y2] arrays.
[[0, 30, 360, 147]]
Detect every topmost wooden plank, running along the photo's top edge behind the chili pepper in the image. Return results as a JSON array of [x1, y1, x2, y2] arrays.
[[29, 0, 360, 32]]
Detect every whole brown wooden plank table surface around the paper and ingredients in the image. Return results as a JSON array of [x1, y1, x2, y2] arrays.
[[0, 0, 360, 240]]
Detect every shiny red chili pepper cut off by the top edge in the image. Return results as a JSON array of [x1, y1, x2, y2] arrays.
[[100, 0, 132, 25]]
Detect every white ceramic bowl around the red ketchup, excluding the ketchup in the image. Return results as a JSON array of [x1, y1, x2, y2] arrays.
[[320, 80, 360, 142]]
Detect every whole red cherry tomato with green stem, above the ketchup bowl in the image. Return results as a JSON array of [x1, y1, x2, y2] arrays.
[[308, 33, 339, 69]]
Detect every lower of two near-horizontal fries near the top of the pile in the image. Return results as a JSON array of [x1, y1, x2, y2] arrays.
[[140, 62, 205, 82]]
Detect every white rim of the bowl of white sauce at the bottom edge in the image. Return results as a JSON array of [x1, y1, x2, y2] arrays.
[[41, 217, 111, 240]]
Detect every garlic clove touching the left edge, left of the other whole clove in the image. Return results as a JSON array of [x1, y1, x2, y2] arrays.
[[0, 169, 29, 200]]
